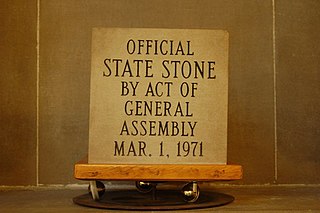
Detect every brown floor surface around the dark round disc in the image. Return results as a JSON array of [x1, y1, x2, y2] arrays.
[[0, 185, 320, 213]]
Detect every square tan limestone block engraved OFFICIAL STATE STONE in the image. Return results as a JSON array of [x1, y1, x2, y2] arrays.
[[88, 28, 229, 164]]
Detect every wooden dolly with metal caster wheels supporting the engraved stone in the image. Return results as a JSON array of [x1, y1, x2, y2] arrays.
[[74, 159, 242, 202]]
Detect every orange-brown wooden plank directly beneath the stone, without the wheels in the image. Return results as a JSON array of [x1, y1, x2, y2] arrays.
[[74, 162, 242, 181]]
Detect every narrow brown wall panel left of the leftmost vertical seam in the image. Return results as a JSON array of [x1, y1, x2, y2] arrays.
[[0, 0, 37, 185]]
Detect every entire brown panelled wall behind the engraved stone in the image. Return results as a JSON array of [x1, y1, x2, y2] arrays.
[[0, 0, 320, 185]]
